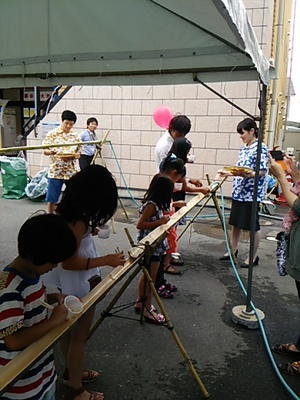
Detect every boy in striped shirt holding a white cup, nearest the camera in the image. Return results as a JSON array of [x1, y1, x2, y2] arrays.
[[0, 214, 76, 400]]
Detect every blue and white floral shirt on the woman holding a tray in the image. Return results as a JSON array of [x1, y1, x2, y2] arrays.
[[232, 140, 269, 202]]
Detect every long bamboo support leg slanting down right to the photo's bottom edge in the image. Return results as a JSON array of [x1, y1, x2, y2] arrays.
[[142, 265, 209, 398]]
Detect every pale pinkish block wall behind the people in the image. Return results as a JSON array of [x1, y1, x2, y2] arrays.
[[28, 0, 270, 196]]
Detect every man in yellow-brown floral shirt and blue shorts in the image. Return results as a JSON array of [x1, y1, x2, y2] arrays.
[[43, 110, 80, 213]]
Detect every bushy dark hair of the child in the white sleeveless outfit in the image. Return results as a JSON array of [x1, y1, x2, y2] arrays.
[[56, 164, 118, 228]]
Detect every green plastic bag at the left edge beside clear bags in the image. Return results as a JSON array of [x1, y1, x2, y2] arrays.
[[0, 156, 27, 199]]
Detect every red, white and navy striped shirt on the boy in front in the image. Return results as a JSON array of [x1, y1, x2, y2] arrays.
[[0, 267, 56, 400]]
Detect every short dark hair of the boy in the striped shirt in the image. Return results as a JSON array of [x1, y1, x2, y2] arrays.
[[18, 214, 77, 265]]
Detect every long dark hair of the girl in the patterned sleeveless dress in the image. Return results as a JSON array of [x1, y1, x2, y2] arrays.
[[142, 174, 174, 211]]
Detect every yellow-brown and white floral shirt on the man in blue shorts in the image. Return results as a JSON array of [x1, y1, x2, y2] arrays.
[[43, 127, 81, 180]]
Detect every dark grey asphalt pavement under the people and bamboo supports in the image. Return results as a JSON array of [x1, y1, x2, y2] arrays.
[[0, 188, 300, 400]]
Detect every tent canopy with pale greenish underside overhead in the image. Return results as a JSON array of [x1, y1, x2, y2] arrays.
[[0, 0, 270, 88]]
